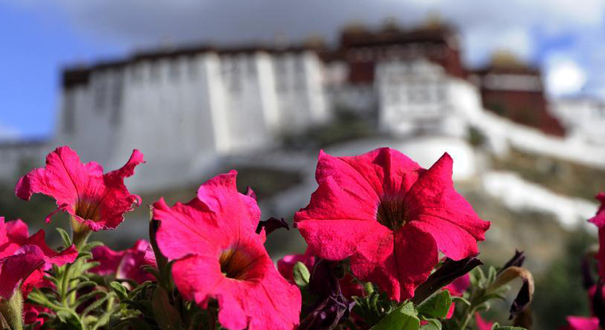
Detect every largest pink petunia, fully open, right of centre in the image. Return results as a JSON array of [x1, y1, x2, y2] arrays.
[[294, 148, 489, 301]]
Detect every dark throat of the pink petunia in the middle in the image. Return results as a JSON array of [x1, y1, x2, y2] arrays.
[[219, 247, 259, 281]]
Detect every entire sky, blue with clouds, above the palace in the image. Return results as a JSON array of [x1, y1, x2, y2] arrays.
[[0, 0, 605, 139]]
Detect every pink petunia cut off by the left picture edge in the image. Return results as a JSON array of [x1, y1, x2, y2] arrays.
[[0, 217, 78, 300]]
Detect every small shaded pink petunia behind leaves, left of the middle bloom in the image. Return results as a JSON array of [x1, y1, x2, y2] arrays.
[[90, 240, 157, 284]]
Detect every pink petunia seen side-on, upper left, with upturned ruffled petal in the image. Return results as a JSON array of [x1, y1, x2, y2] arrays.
[[15, 146, 144, 231]]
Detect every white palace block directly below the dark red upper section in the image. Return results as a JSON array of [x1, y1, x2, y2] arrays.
[[374, 59, 481, 138]]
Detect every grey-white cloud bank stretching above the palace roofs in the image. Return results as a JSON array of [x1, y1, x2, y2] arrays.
[[7, 0, 605, 97]]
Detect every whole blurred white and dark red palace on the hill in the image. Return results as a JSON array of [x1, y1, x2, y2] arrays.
[[0, 25, 600, 189]]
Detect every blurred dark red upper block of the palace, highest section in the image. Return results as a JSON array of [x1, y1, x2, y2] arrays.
[[324, 23, 465, 112]]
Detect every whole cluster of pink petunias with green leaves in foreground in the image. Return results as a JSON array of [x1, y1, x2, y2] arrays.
[[0, 147, 544, 330]]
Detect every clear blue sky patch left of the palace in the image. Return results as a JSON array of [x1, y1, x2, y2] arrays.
[[0, 3, 125, 137]]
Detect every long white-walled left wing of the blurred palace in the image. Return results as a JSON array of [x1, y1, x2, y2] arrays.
[[57, 47, 329, 189]]
